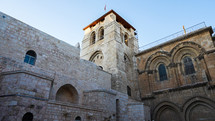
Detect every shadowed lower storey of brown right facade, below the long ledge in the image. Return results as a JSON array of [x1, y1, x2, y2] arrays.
[[144, 85, 215, 121]]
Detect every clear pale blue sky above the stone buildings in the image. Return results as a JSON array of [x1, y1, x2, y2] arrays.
[[0, 0, 215, 46]]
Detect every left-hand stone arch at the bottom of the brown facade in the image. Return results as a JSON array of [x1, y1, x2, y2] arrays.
[[153, 101, 181, 121]]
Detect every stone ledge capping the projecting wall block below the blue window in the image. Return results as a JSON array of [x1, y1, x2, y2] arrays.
[[0, 70, 54, 81]]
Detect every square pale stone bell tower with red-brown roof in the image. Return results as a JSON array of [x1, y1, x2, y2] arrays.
[[81, 10, 138, 95]]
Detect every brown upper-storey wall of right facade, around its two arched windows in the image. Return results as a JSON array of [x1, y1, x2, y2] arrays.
[[137, 27, 215, 96]]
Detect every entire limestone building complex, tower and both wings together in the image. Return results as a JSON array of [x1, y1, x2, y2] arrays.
[[0, 10, 215, 121]]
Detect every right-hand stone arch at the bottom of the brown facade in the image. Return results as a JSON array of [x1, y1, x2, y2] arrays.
[[183, 97, 215, 121]]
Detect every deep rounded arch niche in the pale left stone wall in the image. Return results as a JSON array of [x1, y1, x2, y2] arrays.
[[55, 84, 79, 103]]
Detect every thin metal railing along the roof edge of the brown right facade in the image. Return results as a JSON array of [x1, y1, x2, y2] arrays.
[[139, 22, 206, 51]]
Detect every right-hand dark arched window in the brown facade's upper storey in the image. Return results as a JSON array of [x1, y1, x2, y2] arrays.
[[183, 56, 195, 75]]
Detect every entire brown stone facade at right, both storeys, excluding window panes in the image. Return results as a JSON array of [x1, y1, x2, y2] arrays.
[[136, 27, 215, 121]]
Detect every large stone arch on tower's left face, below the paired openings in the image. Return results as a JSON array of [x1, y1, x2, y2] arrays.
[[89, 51, 104, 68]]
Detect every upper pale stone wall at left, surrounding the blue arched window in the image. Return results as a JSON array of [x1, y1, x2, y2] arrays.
[[0, 13, 111, 89]]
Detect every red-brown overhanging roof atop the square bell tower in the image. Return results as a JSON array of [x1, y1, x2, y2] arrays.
[[83, 10, 136, 30]]
